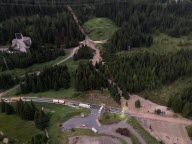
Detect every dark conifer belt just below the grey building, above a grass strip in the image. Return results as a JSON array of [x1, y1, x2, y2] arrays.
[[0, 44, 65, 71]]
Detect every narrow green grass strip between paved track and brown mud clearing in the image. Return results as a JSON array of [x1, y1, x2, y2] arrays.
[[127, 117, 160, 144]]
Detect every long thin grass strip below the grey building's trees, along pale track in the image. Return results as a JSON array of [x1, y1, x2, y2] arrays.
[[1, 49, 71, 77]]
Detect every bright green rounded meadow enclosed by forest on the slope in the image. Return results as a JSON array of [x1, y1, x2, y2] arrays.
[[83, 18, 117, 40]]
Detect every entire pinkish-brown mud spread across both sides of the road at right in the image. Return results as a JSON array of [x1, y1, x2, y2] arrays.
[[122, 95, 192, 144]]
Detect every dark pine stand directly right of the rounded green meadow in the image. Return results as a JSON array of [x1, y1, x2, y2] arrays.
[[105, 21, 153, 53]]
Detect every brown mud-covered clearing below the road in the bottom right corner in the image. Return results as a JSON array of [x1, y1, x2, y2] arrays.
[[138, 118, 192, 144]]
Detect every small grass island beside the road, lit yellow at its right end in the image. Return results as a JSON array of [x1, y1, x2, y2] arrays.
[[99, 113, 126, 125]]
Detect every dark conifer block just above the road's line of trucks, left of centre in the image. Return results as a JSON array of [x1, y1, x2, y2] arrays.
[[20, 66, 70, 93]]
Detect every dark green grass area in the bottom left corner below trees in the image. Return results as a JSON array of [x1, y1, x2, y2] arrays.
[[0, 113, 43, 144]]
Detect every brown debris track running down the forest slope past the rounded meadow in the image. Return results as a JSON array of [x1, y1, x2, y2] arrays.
[[67, 6, 102, 65]]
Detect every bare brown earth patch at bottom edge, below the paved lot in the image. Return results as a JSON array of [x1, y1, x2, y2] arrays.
[[69, 136, 120, 144]]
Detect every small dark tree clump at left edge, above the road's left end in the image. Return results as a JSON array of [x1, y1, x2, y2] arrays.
[[0, 74, 18, 89]]
